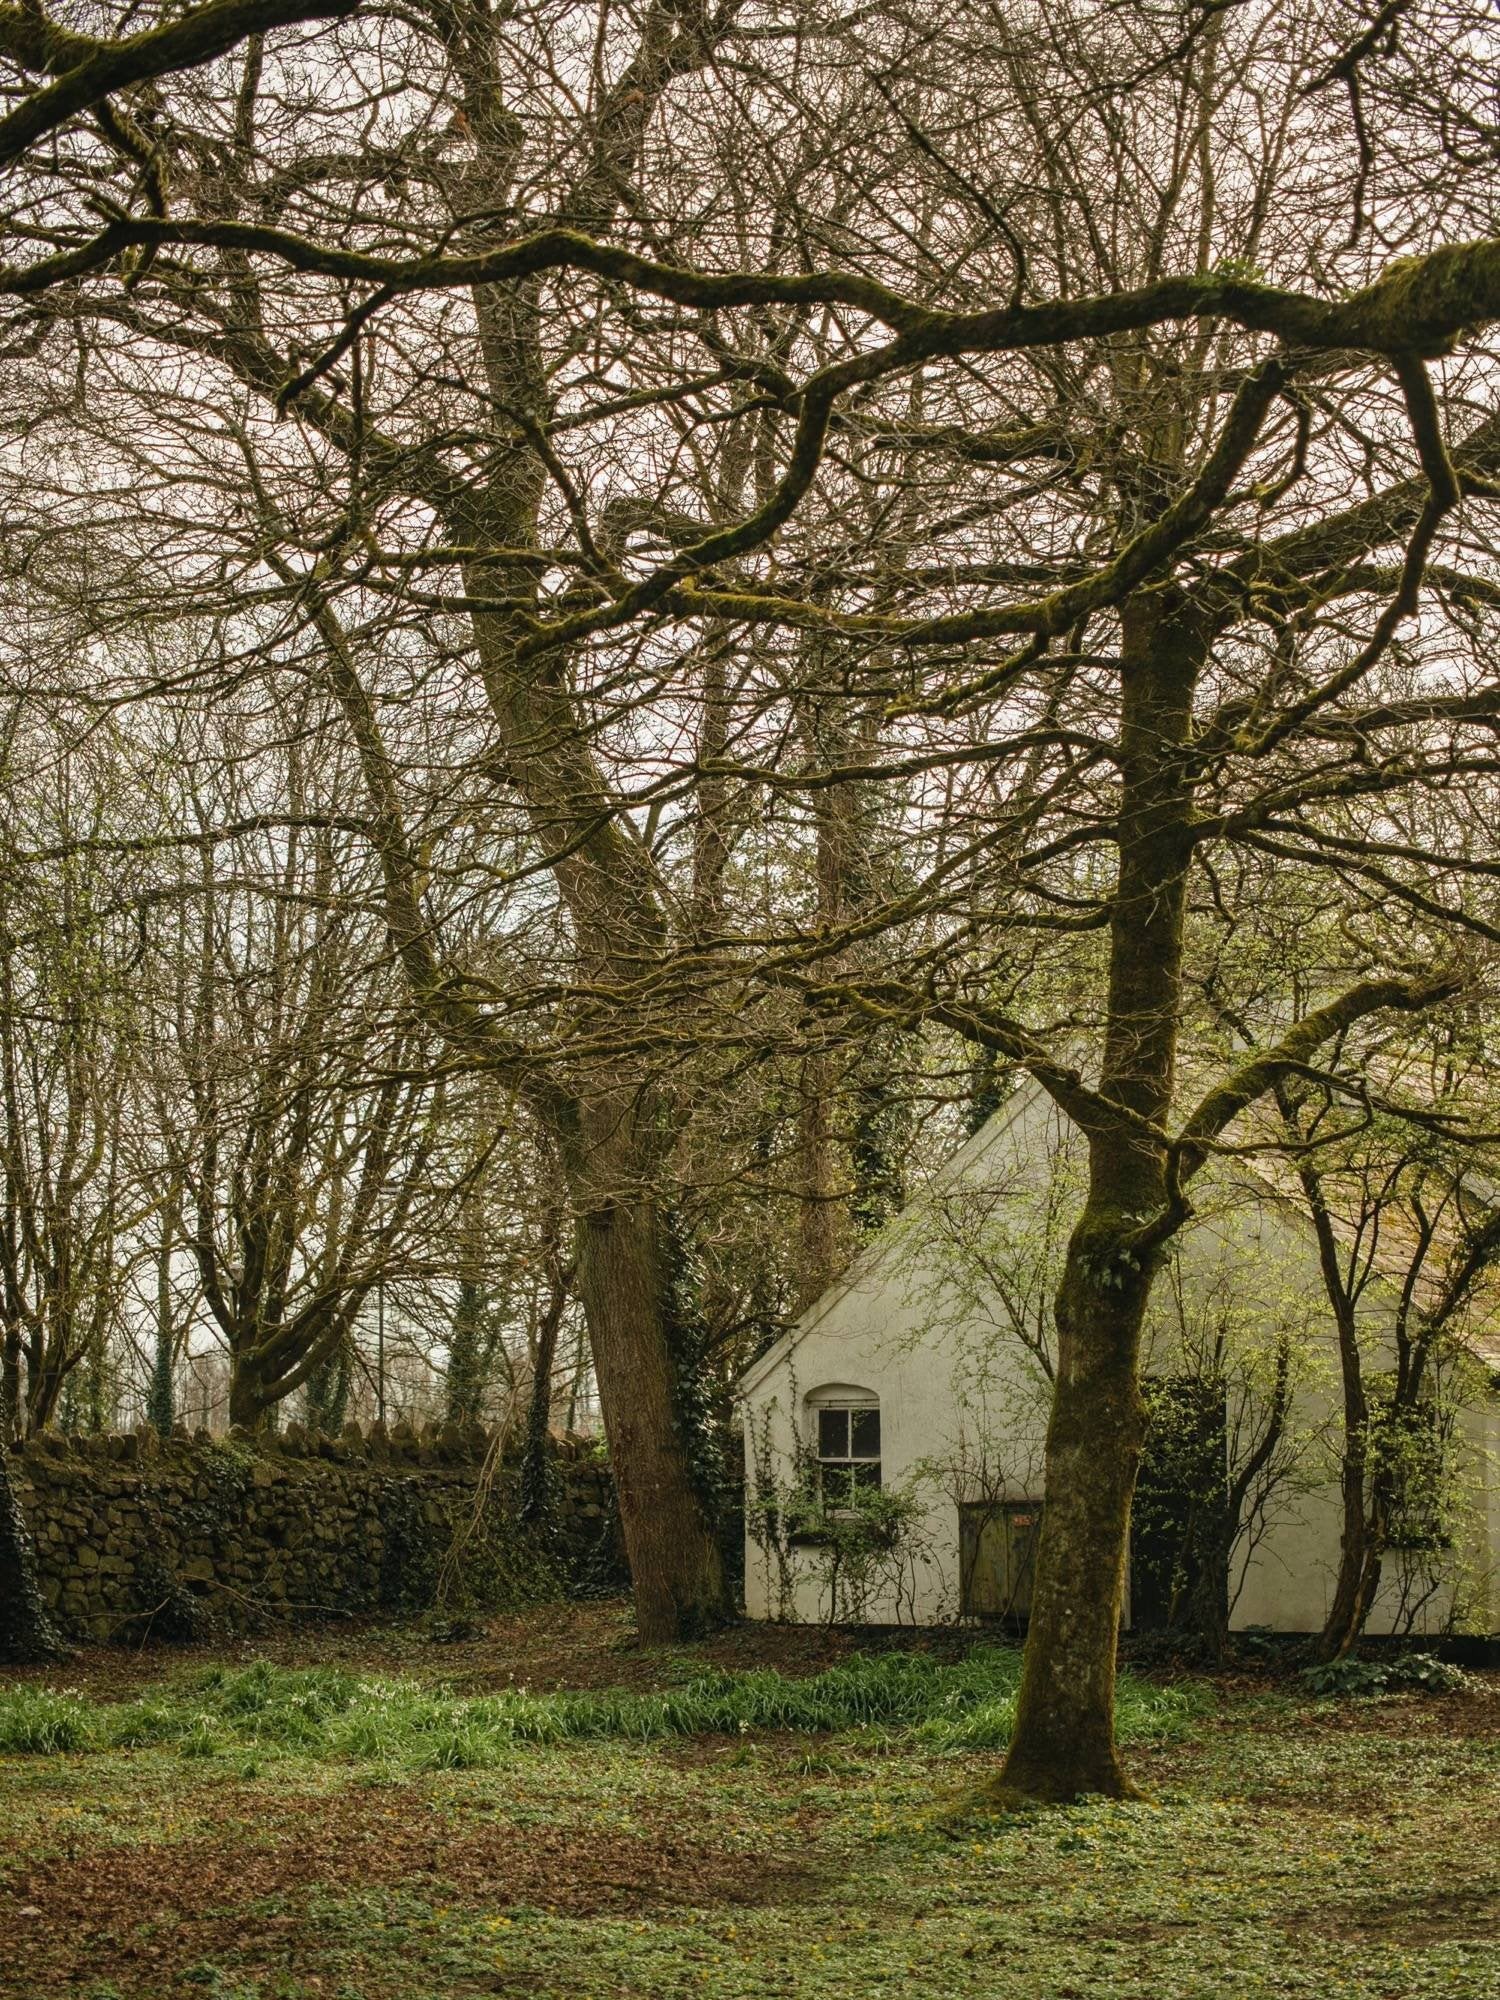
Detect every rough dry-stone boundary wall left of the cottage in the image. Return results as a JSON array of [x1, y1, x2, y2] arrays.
[[12, 1424, 624, 1644]]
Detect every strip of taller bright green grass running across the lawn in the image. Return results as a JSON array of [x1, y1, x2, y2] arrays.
[[0, 1648, 1208, 1770]]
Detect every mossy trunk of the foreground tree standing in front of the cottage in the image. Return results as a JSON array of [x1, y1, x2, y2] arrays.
[[998, 590, 1204, 1800]]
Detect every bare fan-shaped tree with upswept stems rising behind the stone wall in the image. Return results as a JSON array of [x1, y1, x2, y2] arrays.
[[152, 728, 458, 1430]]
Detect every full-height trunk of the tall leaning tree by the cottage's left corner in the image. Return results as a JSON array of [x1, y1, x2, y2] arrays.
[[450, 109, 728, 1644]]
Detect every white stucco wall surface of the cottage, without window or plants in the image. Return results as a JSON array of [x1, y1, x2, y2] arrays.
[[740, 1092, 1500, 1632]]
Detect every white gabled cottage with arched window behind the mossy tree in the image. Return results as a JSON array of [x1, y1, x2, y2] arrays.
[[738, 1086, 1500, 1634]]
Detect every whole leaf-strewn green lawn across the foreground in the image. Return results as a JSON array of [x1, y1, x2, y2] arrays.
[[0, 1616, 1500, 2000]]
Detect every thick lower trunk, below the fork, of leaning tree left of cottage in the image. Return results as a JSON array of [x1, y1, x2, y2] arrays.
[[564, 1098, 726, 1646]]
